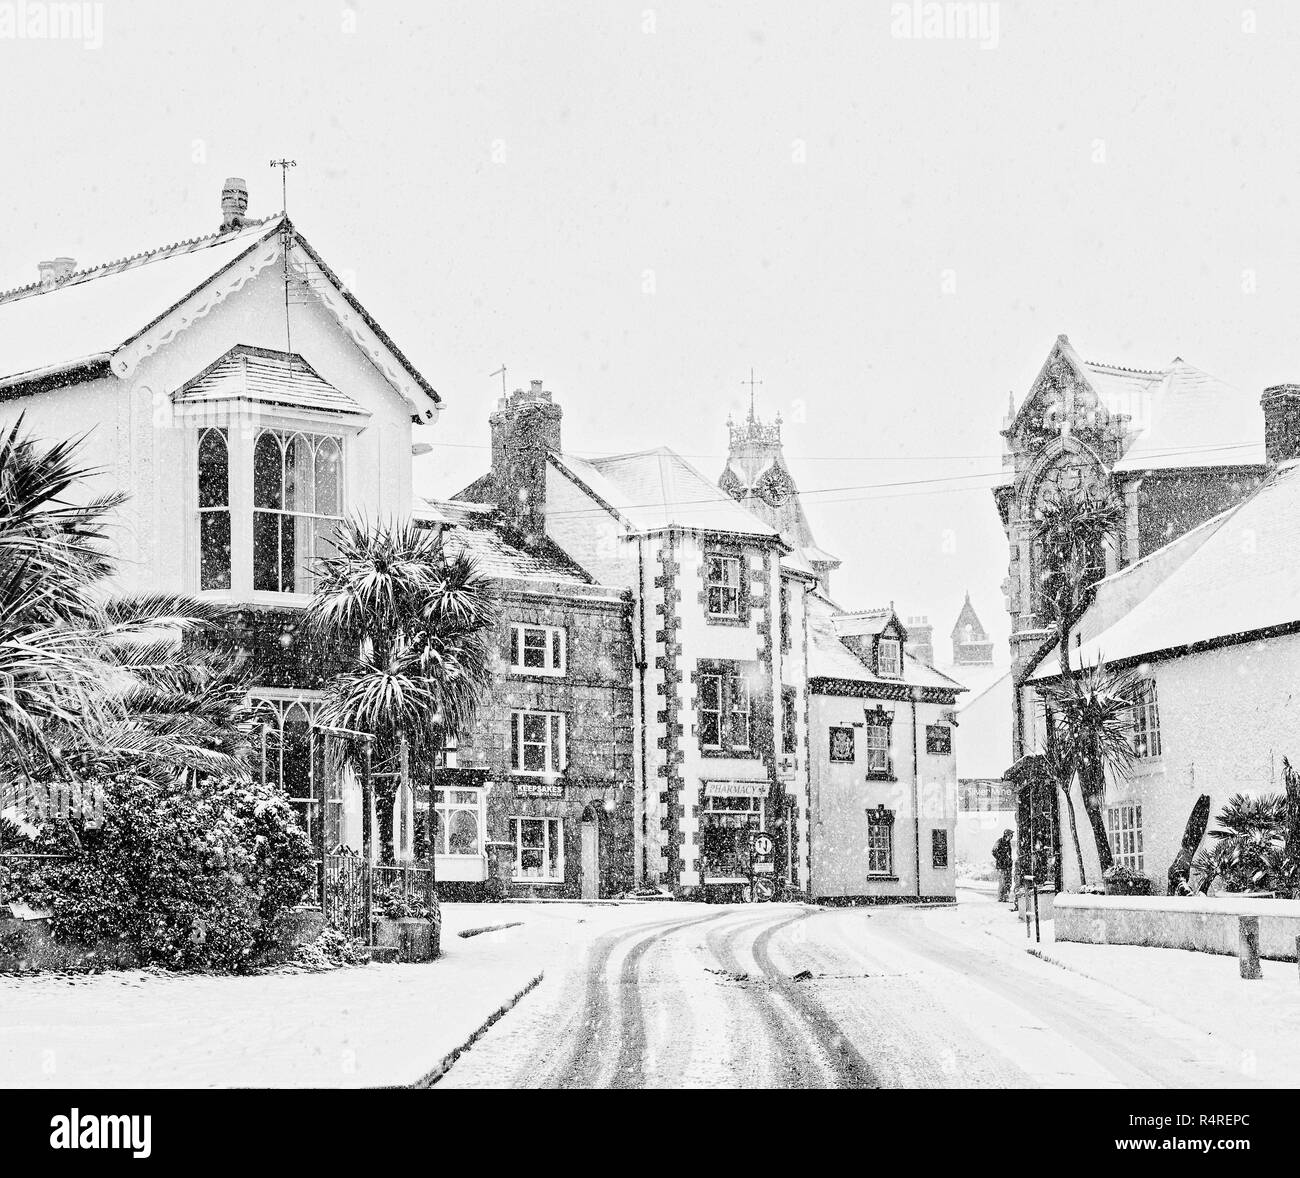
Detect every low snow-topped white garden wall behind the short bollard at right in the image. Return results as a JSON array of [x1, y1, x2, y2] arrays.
[[1054, 893, 1300, 961]]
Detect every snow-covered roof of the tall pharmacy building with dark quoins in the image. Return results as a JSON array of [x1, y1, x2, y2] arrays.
[[551, 446, 779, 540]]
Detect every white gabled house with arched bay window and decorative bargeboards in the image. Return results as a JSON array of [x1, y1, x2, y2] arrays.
[[0, 181, 439, 849]]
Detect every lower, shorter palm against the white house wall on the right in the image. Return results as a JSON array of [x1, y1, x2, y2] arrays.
[[1041, 662, 1141, 883]]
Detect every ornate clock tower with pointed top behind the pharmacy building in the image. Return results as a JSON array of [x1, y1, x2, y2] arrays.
[[718, 400, 840, 594]]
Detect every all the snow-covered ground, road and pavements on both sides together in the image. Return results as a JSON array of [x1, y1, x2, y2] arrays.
[[0, 892, 1300, 1091]]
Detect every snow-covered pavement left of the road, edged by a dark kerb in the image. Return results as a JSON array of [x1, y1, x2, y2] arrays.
[[0, 904, 683, 1088]]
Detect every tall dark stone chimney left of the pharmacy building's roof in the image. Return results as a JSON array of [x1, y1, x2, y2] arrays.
[[488, 381, 563, 543]]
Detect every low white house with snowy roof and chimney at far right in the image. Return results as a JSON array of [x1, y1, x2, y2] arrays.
[[1027, 385, 1300, 892]]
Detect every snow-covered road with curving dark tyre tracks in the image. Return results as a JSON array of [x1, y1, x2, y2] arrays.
[[438, 896, 1297, 1088]]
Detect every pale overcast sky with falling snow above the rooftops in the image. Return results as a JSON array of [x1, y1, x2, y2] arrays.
[[0, 0, 1300, 655]]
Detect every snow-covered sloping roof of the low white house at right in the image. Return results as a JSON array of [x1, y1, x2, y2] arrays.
[[1030, 464, 1300, 680]]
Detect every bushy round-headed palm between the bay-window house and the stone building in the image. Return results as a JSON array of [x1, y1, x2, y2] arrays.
[[307, 520, 497, 848]]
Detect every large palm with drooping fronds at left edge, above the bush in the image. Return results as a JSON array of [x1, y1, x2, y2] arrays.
[[0, 417, 256, 809]]
